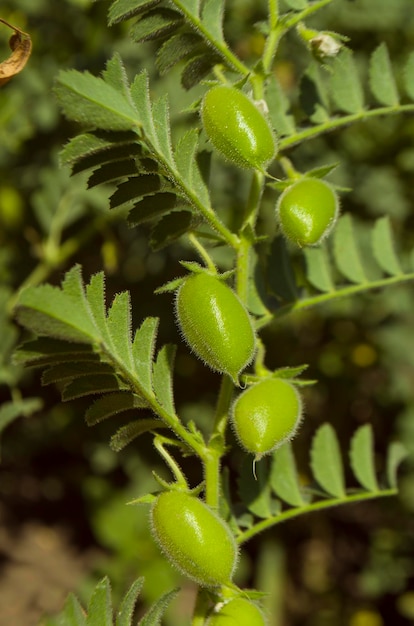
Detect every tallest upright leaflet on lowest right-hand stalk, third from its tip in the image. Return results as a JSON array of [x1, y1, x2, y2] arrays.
[[311, 424, 345, 498]]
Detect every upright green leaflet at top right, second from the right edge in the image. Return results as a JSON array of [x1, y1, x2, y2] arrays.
[[369, 43, 399, 106]]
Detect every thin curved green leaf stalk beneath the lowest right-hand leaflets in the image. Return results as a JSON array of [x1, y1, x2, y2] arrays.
[[236, 489, 398, 545]]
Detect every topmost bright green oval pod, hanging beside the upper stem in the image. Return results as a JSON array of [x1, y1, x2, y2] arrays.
[[201, 85, 276, 169]]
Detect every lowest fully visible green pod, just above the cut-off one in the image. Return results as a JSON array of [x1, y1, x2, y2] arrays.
[[151, 491, 237, 587]]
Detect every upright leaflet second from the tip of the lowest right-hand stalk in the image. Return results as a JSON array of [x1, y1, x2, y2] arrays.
[[349, 424, 379, 491]]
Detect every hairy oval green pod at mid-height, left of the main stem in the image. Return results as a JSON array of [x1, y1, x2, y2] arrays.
[[175, 272, 255, 381]]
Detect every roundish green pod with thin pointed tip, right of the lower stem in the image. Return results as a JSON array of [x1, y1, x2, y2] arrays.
[[231, 378, 302, 459]]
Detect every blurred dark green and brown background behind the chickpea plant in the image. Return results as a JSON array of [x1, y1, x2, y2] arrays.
[[0, 0, 414, 626]]
